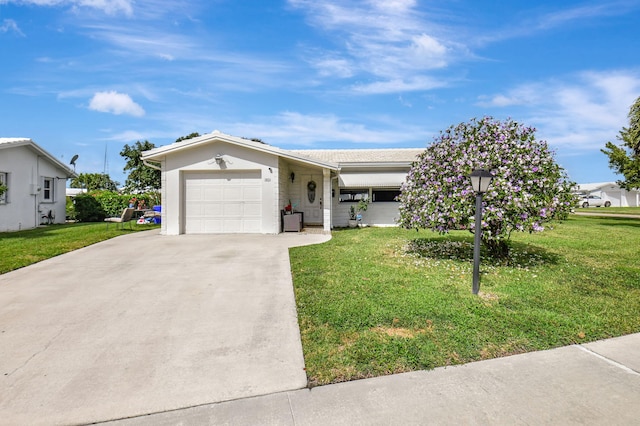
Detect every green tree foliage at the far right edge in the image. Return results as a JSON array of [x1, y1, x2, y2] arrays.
[[601, 97, 640, 189]]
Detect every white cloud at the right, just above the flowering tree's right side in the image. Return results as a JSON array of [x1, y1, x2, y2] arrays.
[[478, 70, 640, 151]]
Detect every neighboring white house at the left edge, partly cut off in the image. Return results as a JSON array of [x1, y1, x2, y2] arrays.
[[0, 138, 75, 232]]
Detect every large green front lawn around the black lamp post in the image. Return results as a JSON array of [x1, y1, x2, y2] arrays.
[[291, 216, 640, 385]]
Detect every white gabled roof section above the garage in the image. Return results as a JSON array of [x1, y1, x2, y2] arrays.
[[142, 130, 338, 170]]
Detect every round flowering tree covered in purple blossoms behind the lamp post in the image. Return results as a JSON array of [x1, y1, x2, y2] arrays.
[[399, 117, 575, 257]]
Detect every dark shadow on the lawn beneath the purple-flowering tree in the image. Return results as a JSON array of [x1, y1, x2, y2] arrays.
[[407, 236, 560, 268]]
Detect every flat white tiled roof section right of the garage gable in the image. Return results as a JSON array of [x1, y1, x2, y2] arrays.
[[289, 148, 425, 165]]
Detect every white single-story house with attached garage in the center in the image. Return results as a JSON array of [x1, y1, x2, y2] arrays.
[[142, 131, 424, 235]]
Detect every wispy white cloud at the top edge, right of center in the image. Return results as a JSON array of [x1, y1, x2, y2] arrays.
[[289, 0, 467, 93]]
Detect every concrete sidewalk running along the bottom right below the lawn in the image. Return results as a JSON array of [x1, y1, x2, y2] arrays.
[[108, 333, 640, 426]]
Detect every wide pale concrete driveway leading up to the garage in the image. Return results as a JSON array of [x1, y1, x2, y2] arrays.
[[0, 231, 329, 424]]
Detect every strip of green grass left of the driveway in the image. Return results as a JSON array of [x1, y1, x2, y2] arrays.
[[0, 222, 160, 274]]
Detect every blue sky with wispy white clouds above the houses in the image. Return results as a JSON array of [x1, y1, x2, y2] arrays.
[[0, 0, 640, 184]]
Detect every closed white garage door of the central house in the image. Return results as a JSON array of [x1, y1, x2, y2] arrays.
[[184, 170, 262, 234]]
